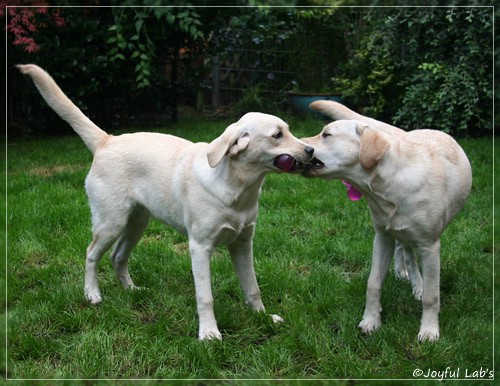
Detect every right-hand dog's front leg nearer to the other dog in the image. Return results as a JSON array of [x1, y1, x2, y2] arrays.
[[359, 232, 394, 334]]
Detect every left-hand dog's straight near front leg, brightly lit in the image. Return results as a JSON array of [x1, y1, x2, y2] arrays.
[[189, 238, 222, 340]]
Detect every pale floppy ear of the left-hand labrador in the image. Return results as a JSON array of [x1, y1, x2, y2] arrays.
[[207, 123, 250, 168]]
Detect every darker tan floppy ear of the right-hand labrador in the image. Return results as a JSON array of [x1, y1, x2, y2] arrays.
[[356, 124, 391, 170]]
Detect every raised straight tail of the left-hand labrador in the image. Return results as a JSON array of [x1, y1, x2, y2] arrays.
[[16, 64, 109, 154]]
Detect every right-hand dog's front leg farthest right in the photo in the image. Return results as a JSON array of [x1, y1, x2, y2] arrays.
[[418, 240, 441, 341]]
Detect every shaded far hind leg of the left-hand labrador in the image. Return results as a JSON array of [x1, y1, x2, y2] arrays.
[[110, 208, 150, 289]]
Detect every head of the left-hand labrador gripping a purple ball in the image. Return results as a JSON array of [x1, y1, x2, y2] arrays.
[[207, 113, 314, 172]]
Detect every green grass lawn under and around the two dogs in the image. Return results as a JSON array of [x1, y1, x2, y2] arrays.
[[4, 119, 493, 384]]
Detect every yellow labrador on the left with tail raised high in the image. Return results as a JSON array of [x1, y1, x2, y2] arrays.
[[18, 64, 314, 340]]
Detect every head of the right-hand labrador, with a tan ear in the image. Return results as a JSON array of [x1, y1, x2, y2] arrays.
[[302, 120, 390, 178]]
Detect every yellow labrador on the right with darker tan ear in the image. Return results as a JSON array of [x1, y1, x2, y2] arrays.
[[303, 101, 472, 341]]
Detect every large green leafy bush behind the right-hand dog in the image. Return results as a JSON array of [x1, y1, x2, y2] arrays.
[[334, 7, 493, 135]]
